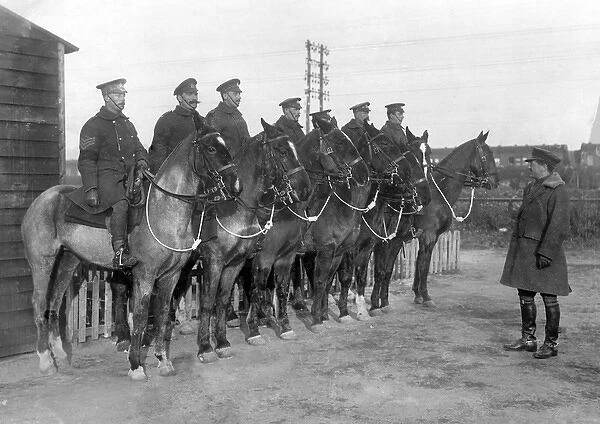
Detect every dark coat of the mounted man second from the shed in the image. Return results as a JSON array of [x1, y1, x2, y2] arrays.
[[149, 105, 204, 173]]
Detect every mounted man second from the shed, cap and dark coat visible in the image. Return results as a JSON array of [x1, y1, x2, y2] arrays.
[[149, 78, 204, 173]]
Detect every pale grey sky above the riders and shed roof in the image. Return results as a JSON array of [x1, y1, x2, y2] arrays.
[[0, 0, 600, 159]]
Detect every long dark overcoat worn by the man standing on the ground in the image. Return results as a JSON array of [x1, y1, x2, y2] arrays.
[[500, 172, 571, 296]]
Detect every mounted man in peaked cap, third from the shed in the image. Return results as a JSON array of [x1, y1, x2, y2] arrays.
[[206, 78, 250, 157]]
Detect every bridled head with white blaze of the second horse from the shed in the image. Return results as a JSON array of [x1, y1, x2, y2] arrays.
[[260, 118, 312, 206]]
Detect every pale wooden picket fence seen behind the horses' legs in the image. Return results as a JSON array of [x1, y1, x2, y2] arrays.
[[66, 231, 460, 343]]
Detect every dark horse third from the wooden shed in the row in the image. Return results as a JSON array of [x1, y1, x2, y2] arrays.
[[240, 117, 369, 344]]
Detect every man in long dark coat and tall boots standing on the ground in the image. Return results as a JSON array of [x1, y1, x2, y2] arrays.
[[500, 147, 571, 359]]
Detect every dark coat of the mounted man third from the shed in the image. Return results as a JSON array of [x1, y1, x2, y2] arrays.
[[206, 102, 250, 157]]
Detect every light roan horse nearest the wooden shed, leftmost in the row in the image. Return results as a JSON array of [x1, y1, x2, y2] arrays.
[[21, 127, 239, 380]]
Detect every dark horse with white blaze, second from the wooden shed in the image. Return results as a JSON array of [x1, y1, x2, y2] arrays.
[[195, 121, 310, 362]]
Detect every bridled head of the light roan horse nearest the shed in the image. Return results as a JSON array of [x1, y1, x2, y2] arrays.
[[190, 125, 242, 201]]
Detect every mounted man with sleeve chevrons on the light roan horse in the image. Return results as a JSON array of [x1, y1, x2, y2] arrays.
[[77, 78, 148, 268]]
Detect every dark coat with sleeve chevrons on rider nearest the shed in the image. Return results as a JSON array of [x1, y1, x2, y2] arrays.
[[77, 106, 148, 210]]
